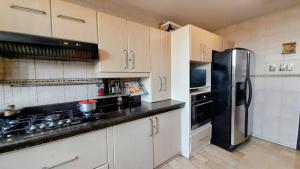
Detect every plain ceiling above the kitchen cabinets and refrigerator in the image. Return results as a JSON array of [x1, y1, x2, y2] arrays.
[[69, 0, 300, 31]]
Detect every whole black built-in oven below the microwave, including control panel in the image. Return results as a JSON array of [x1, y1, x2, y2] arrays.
[[191, 93, 213, 130]]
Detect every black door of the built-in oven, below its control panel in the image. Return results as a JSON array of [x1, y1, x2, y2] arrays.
[[191, 100, 213, 130]]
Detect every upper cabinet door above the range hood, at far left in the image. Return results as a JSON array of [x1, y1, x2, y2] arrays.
[[0, 0, 51, 37]]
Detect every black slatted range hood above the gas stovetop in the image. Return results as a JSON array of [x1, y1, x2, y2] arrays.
[[0, 31, 98, 61]]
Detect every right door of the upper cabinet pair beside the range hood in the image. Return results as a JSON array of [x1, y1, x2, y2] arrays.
[[127, 21, 150, 72]]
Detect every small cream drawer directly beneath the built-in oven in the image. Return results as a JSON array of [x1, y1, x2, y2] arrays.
[[191, 124, 212, 150]]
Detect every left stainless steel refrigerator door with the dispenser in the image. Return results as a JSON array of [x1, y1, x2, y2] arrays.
[[231, 49, 249, 146]]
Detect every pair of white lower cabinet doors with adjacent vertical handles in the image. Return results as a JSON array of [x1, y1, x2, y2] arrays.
[[113, 109, 181, 169]]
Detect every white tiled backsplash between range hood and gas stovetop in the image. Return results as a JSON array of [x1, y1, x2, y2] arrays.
[[0, 57, 101, 110]]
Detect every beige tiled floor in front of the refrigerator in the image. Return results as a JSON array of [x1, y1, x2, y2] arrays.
[[159, 138, 300, 169]]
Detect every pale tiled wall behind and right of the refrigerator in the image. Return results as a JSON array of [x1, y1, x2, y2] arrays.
[[216, 5, 300, 148]]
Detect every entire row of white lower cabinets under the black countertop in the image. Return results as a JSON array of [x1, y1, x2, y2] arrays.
[[0, 109, 181, 169]]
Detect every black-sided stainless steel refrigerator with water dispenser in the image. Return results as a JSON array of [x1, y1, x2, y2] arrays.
[[211, 48, 255, 151]]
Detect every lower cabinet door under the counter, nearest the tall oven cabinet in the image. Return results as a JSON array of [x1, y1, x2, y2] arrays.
[[153, 109, 181, 168]]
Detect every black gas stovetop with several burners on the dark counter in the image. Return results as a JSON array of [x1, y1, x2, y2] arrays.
[[0, 109, 105, 139]]
